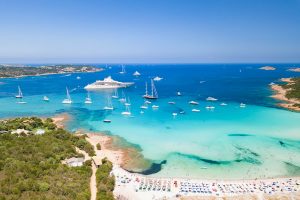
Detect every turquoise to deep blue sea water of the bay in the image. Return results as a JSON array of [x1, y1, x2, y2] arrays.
[[0, 64, 300, 178]]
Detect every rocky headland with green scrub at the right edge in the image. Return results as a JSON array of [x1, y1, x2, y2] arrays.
[[271, 77, 300, 111]]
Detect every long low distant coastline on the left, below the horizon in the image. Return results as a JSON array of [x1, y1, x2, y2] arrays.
[[0, 64, 103, 78]]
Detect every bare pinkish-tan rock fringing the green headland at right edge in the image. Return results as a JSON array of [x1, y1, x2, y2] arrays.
[[271, 78, 300, 111]]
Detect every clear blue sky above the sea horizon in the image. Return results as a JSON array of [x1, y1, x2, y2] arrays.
[[0, 0, 300, 63]]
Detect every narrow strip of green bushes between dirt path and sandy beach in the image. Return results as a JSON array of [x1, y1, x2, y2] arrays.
[[96, 159, 115, 200]]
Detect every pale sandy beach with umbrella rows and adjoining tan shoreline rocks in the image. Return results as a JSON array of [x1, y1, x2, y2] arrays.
[[53, 113, 300, 200]]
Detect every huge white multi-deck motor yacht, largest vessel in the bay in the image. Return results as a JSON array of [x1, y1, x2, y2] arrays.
[[84, 76, 134, 90]]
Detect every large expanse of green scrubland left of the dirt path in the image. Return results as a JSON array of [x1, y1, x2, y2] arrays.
[[0, 117, 91, 200]]
